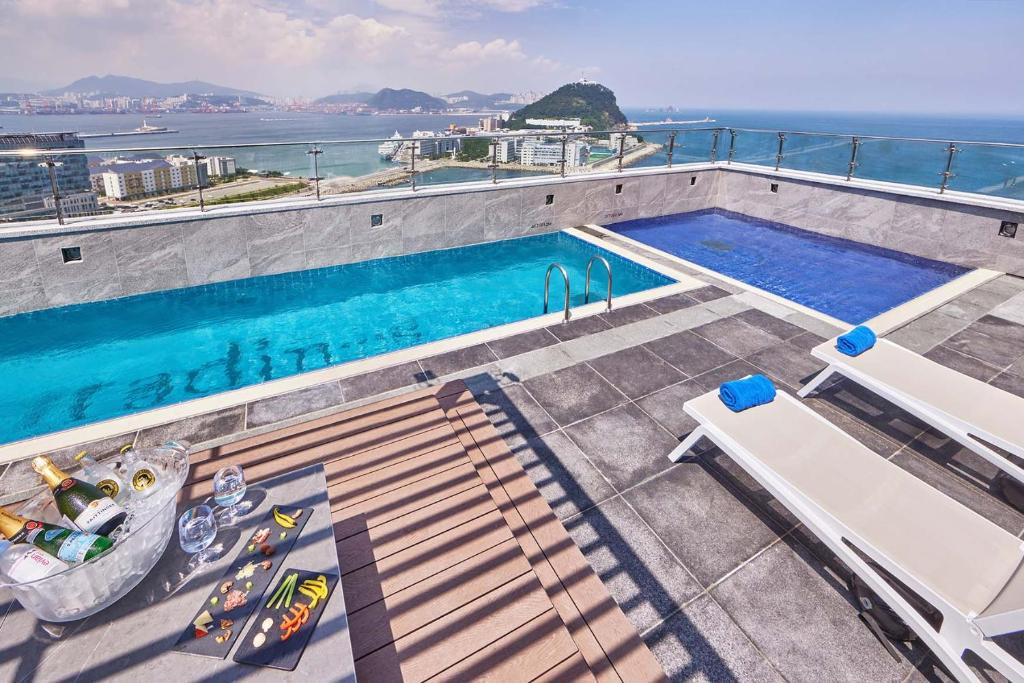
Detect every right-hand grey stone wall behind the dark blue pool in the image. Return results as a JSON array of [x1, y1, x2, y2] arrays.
[[716, 171, 1024, 275]]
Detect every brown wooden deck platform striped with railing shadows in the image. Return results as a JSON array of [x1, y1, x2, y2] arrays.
[[185, 382, 665, 683]]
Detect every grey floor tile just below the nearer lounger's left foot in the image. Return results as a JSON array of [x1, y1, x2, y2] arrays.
[[623, 461, 780, 588]]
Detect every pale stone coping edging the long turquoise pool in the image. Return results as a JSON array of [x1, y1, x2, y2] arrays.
[[0, 228, 707, 466]]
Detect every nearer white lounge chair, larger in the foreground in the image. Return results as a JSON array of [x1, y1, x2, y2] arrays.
[[669, 392, 1024, 681]]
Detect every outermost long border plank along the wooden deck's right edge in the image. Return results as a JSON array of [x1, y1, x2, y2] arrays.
[[442, 391, 665, 681]]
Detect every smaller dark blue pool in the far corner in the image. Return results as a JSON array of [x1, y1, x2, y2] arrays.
[[611, 209, 968, 325]]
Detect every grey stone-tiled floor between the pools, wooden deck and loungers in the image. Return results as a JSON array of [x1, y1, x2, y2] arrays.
[[5, 228, 1024, 681]]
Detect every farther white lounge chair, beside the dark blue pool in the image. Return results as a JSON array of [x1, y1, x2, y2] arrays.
[[799, 339, 1024, 482]]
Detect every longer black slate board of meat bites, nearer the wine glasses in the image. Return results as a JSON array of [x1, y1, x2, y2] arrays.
[[174, 505, 313, 659]]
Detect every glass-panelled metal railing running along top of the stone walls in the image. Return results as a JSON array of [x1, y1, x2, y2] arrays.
[[0, 127, 1024, 223]]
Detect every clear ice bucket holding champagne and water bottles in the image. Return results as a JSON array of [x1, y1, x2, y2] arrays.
[[0, 442, 188, 622]]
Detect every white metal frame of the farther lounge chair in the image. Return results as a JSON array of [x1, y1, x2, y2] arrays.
[[797, 339, 1024, 483]]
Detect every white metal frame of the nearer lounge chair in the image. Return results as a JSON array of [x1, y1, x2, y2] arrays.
[[669, 392, 1024, 683]]
